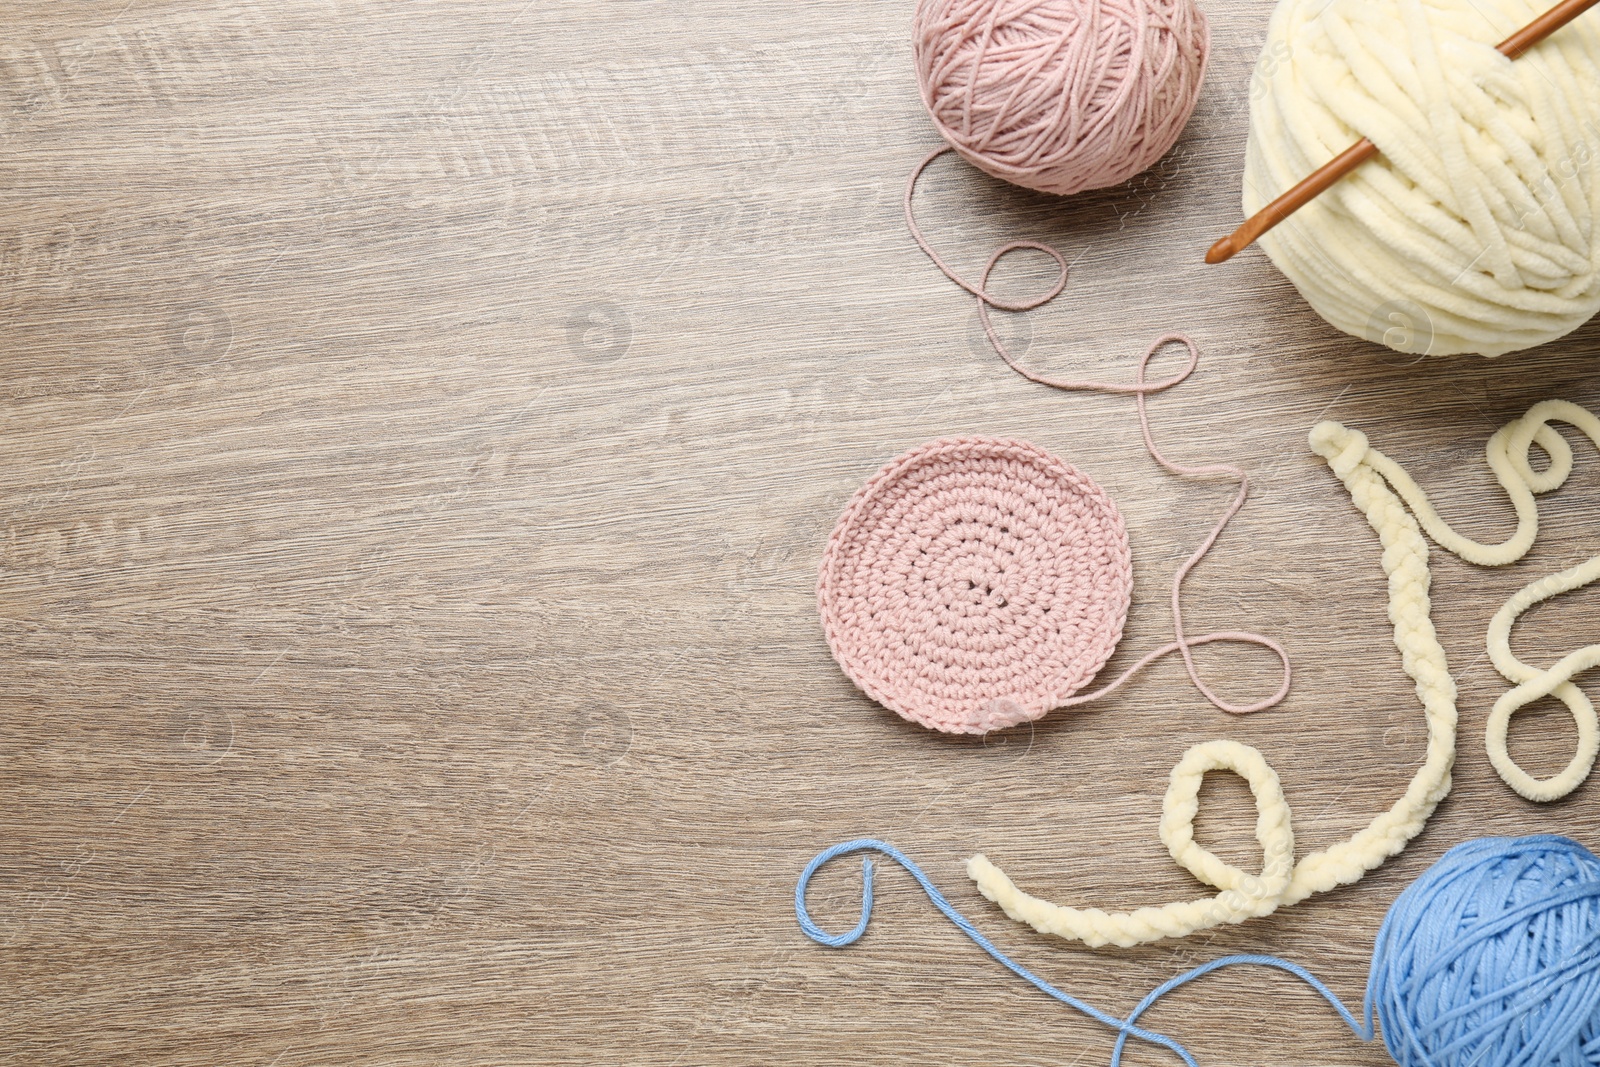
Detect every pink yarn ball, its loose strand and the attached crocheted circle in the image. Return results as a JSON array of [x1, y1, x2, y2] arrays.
[[851, 0, 1291, 733]]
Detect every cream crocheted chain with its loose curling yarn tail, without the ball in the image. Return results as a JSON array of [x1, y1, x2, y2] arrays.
[[966, 400, 1600, 947]]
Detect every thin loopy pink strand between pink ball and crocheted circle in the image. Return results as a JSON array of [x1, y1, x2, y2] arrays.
[[906, 146, 1293, 715]]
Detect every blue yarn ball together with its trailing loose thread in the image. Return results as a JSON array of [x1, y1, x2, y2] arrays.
[[795, 833, 1600, 1067]]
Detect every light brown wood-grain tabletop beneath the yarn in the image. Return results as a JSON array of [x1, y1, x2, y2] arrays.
[[0, 0, 1600, 1067]]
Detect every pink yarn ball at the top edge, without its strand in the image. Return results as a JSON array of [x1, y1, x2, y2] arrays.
[[912, 0, 1211, 195]]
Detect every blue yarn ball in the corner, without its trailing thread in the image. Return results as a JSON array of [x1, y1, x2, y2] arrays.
[[1366, 833, 1600, 1067]]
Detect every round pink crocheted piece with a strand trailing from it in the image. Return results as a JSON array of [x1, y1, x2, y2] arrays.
[[818, 437, 1133, 734]]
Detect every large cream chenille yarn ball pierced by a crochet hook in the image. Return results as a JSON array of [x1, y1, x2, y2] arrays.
[[1245, 0, 1600, 355]]
